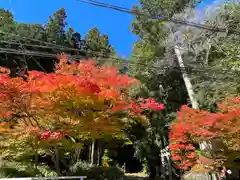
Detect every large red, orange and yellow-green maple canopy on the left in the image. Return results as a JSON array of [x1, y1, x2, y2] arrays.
[[0, 58, 164, 152]]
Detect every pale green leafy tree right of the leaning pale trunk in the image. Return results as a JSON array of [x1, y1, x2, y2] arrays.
[[178, 2, 240, 111]]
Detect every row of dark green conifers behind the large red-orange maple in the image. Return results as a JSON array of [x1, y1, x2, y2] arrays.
[[0, 8, 114, 73]]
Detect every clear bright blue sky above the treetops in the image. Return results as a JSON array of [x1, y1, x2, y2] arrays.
[[0, 0, 216, 57]]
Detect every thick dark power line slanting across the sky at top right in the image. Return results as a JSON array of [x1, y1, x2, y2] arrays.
[[76, 0, 240, 35]]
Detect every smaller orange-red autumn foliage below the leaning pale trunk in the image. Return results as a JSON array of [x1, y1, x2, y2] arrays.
[[169, 97, 240, 170]]
